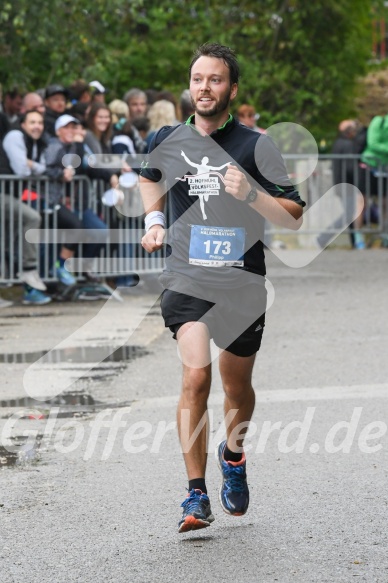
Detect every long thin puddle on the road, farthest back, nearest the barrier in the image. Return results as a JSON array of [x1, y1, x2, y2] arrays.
[[0, 346, 148, 364]]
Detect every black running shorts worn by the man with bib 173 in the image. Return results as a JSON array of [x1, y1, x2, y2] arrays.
[[161, 285, 267, 356]]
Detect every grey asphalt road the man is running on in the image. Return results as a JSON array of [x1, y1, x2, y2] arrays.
[[0, 249, 388, 583]]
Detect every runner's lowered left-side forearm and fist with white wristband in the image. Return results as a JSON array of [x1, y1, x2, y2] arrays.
[[139, 176, 166, 253]]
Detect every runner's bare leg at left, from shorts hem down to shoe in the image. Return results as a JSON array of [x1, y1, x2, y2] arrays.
[[177, 322, 214, 532]]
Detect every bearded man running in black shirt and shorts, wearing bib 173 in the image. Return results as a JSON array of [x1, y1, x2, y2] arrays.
[[140, 43, 304, 532]]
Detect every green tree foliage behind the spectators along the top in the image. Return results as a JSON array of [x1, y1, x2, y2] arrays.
[[0, 0, 381, 139]]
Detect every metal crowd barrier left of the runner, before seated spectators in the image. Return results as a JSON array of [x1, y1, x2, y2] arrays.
[[0, 175, 164, 285]]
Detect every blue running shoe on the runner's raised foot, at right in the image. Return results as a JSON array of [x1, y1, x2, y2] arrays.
[[216, 441, 249, 516]]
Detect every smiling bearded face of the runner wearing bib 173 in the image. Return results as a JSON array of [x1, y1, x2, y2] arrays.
[[190, 57, 237, 117]]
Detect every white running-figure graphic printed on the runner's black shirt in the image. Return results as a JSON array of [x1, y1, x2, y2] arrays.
[[176, 150, 231, 220]]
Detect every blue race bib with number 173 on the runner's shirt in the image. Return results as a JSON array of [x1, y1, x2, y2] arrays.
[[189, 225, 245, 267]]
